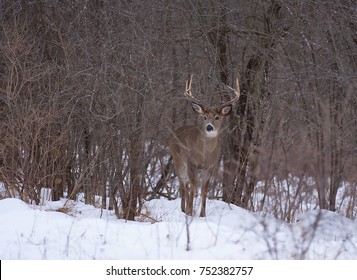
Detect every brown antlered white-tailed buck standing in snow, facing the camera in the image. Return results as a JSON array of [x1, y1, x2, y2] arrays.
[[169, 76, 240, 217]]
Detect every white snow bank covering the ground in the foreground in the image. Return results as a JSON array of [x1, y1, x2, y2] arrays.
[[0, 198, 357, 260]]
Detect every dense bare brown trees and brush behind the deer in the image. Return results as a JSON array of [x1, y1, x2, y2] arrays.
[[0, 0, 357, 221]]
